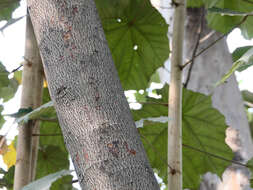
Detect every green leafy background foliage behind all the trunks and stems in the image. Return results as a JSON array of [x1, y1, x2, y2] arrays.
[[0, 0, 253, 190]]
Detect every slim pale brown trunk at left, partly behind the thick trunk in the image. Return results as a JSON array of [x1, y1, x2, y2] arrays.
[[14, 16, 43, 190]]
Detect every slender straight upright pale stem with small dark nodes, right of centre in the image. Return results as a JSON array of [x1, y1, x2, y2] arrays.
[[168, 0, 186, 190]]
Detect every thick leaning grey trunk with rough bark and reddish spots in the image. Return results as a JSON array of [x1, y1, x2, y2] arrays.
[[28, 0, 159, 190]]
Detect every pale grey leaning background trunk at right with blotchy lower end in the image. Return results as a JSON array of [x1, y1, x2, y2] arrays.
[[185, 8, 253, 190]]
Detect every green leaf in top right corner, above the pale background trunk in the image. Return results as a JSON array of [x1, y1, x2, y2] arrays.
[[207, 0, 253, 39]]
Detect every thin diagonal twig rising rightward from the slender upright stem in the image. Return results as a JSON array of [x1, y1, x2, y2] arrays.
[[181, 15, 249, 69]]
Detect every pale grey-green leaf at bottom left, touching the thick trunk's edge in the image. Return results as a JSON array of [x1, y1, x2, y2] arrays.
[[22, 170, 71, 190]]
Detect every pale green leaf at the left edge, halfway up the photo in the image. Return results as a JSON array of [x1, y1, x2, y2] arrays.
[[0, 62, 18, 102]]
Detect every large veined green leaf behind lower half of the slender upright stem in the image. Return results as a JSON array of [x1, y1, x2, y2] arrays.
[[133, 86, 233, 189]]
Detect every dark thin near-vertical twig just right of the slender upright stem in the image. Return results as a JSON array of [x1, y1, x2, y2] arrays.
[[184, 8, 204, 88]]
